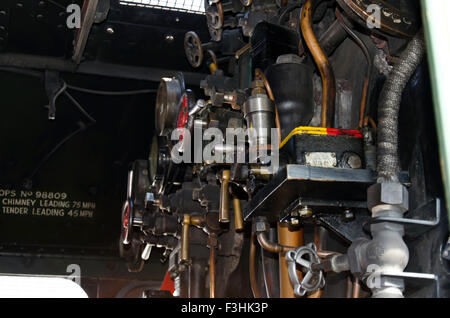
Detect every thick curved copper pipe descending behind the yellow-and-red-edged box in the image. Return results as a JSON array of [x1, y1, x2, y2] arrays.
[[300, 0, 336, 128]]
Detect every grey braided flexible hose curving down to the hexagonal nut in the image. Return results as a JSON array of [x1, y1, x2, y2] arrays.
[[377, 32, 425, 183]]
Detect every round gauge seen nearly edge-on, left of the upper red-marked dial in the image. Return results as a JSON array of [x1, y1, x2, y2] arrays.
[[155, 76, 184, 135]]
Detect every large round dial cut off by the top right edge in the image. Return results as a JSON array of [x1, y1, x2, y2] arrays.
[[337, 0, 419, 37]]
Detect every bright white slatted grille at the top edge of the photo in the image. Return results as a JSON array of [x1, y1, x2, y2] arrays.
[[120, 0, 205, 14]]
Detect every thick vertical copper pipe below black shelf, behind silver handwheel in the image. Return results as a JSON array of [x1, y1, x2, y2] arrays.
[[278, 222, 303, 298]]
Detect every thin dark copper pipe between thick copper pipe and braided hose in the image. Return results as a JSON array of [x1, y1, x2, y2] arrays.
[[336, 8, 372, 128]]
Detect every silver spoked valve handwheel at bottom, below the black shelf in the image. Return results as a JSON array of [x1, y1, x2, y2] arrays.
[[286, 243, 325, 297]]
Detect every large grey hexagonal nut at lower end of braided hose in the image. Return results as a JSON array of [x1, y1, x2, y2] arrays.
[[367, 182, 409, 213]]
